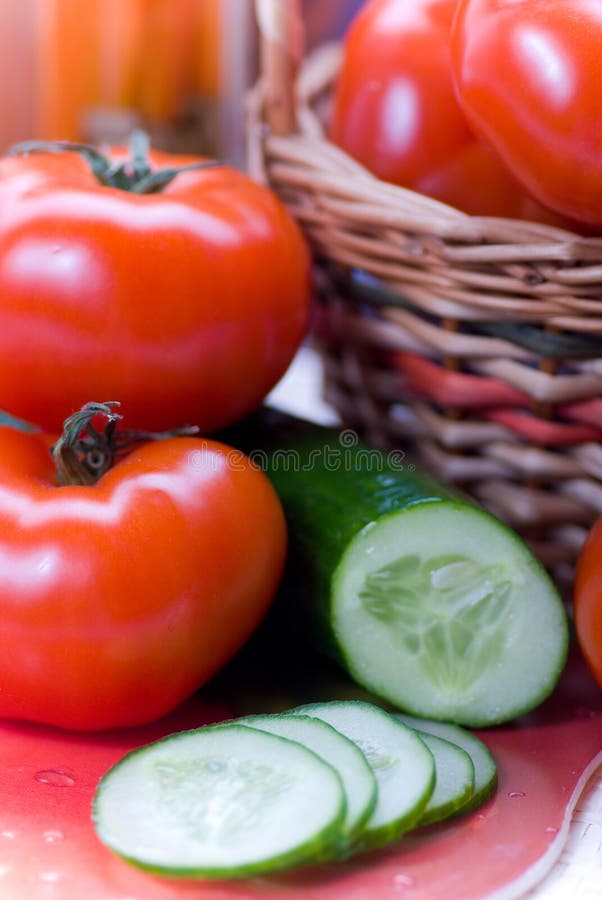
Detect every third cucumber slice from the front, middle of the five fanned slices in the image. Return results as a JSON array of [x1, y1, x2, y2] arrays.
[[291, 700, 435, 850]]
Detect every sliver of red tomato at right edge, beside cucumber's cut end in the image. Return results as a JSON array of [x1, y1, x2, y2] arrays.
[[574, 517, 602, 688]]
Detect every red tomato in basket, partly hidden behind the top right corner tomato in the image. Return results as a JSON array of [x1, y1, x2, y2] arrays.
[[331, 0, 553, 220]]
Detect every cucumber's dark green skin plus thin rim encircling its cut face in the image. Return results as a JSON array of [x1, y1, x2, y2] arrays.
[[222, 409, 569, 727]]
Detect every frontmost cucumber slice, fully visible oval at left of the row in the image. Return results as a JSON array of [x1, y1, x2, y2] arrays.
[[93, 723, 346, 878]]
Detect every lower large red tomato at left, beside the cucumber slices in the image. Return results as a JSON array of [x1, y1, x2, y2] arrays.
[[0, 404, 285, 729]]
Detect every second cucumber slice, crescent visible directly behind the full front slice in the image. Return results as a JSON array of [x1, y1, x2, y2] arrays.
[[236, 715, 377, 853]]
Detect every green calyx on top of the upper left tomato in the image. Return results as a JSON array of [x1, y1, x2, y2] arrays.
[[6, 131, 221, 194]]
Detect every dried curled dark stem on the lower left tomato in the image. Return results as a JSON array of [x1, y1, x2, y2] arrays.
[[51, 400, 198, 487]]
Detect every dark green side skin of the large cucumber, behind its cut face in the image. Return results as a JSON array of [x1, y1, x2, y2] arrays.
[[220, 408, 462, 668]]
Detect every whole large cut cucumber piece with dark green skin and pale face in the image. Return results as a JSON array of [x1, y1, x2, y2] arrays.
[[227, 410, 568, 726]]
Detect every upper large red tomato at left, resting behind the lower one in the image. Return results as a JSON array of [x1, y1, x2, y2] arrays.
[[0, 139, 310, 431]]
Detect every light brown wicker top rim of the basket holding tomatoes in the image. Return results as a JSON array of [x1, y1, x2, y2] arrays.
[[247, 41, 602, 250]]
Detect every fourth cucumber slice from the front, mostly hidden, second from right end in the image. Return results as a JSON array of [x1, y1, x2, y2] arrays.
[[417, 732, 474, 826]]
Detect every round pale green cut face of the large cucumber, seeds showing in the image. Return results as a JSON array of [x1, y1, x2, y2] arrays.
[[330, 501, 568, 726]]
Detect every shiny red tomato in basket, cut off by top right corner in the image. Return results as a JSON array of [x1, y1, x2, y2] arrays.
[[452, 0, 602, 225]]
